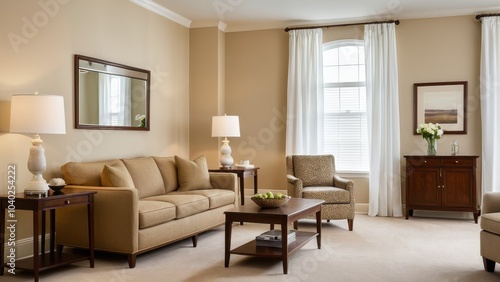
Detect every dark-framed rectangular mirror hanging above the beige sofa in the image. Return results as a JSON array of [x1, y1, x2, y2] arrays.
[[74, 55, 151, 131]]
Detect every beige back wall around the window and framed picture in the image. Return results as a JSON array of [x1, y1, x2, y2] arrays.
[[208, 15, 481, 214]]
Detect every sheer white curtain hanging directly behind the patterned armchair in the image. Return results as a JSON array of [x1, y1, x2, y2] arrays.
[[286, 29, 323, 155]]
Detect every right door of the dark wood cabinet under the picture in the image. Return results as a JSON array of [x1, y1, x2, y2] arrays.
[[443, 168, 474, 208]]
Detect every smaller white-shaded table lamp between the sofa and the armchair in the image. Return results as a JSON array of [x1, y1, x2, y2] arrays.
[[212, 115, 240, 168]]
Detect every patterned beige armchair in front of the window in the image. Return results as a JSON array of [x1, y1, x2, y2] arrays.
[[286, 155, 354, 231]]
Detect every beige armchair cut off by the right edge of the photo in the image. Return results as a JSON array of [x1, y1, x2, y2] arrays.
[[479, 192, 500, 272]]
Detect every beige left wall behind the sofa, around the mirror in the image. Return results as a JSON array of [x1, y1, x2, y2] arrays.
[[0, 0, 189, 242]]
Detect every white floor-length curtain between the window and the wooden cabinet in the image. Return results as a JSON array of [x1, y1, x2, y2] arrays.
[[364, 23, 403, 216]]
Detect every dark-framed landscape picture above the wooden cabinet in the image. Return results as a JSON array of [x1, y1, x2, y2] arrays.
[[413, 81, 467, 135]]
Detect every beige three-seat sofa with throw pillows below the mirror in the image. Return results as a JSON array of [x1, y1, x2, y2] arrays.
[[56, 156, 239, 268]]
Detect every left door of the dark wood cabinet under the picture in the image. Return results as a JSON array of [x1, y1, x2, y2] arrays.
[[408, 167, 441, 207]]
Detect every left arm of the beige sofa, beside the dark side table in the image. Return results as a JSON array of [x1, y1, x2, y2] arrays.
[[56, 185, 139, 254]]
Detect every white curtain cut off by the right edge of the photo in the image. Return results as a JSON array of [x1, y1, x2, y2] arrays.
[[480, 17, 500, 193]]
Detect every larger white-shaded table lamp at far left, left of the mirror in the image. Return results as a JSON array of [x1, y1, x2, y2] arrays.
[[10, 93, 66, 196]]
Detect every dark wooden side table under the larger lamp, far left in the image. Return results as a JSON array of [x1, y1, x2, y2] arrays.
[[0, 189, 96, 281]]
